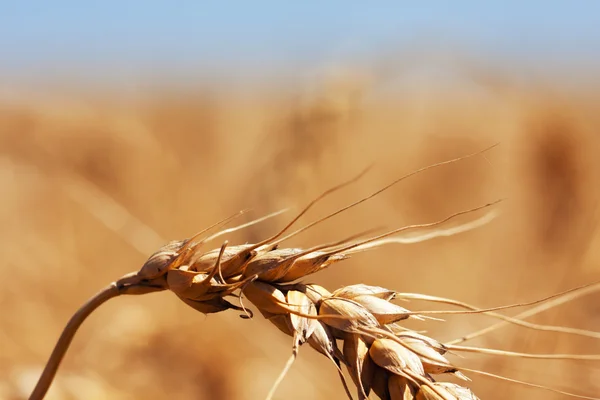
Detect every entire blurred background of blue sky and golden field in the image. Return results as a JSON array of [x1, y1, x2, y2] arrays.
[[0, 1, 600, 400]]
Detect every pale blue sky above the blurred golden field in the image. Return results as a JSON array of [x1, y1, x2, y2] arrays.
[[0, 0, 600, 86]]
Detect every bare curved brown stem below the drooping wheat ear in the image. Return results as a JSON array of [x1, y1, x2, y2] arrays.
[[29, 282, 121, 400]]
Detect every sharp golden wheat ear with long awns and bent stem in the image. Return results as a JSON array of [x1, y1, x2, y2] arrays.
[[24, 145, 600, 400]]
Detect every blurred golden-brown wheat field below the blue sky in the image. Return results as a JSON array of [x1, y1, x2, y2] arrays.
[[0, 73, 600, 400]]
